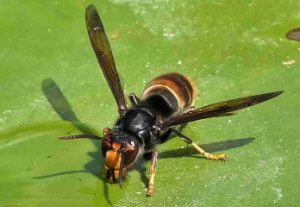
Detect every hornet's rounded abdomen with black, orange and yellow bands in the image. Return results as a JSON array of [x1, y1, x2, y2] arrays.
[[142, 73, 196, 116]]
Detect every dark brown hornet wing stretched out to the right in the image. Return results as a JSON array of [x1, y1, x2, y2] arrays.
[[161, 91, 283, 130]]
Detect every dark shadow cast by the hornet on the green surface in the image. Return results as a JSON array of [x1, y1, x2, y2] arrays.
[[34, 78, 255, 199]]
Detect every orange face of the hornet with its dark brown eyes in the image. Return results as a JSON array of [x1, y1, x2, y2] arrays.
[[102, 133, 139, 182]]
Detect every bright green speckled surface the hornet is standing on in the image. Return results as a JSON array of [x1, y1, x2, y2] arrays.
[[0, 0, 300, 207]]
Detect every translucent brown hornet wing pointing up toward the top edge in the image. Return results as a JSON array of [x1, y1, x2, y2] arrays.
[[85, 5, 127, 114]]
